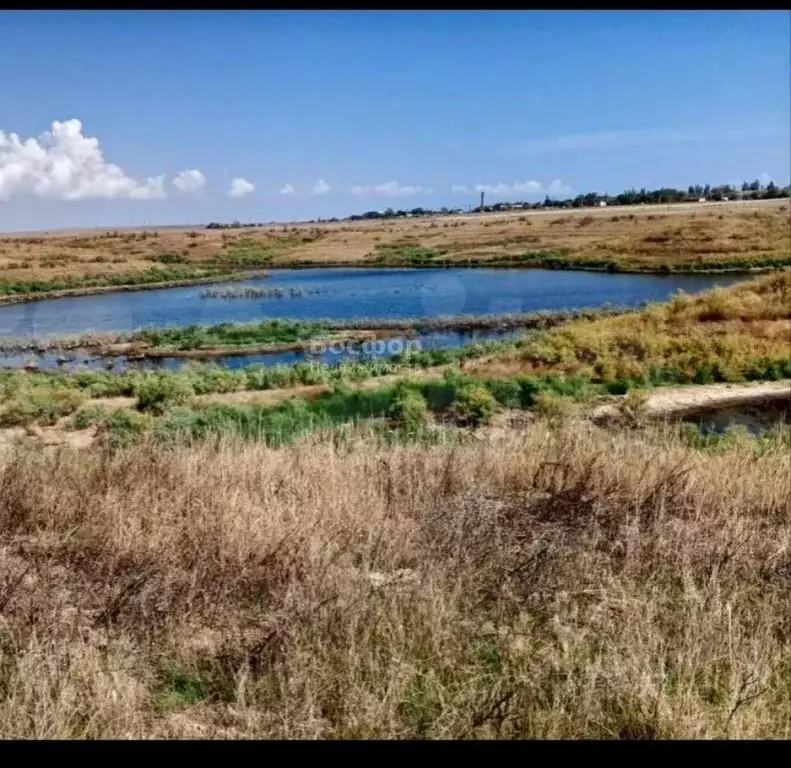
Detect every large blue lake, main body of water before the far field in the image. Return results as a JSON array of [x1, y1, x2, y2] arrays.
[[0, 268, 745, 339]]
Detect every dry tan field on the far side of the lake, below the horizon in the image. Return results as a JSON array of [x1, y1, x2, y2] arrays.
[[0, 200, 791, 280]]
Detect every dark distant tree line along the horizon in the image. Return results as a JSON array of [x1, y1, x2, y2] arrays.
[[206, 179, 791, 229]]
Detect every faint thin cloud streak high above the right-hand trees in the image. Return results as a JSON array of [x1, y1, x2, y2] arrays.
[[508, 125, 788, 155]]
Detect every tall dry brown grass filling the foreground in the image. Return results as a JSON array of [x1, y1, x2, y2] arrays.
[[0, 421, 791, 738]]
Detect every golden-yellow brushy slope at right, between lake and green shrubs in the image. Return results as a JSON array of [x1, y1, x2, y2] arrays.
[[467, 270, 791, 381]]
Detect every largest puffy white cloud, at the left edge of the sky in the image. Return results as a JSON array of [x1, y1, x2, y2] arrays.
[[0, 119, 165, 201]]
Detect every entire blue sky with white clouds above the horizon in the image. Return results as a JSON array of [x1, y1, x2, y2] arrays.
[[0, 11, 791, 231]]
